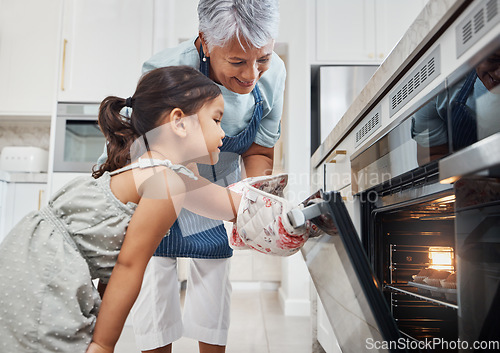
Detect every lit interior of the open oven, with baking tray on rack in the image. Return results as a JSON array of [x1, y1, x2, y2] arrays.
[[373, 191, 458, 342]]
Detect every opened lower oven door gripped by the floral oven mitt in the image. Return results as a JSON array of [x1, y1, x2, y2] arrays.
[[302, 192, 404, 353]]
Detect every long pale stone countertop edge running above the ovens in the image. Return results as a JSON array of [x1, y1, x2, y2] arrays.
[[311, 0, 467, 169]]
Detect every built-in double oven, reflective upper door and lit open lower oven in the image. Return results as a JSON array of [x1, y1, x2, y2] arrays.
[[351, 10, 500, 346]]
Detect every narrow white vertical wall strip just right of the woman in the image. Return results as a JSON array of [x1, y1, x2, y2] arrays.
[[277, 0, 310, 316]]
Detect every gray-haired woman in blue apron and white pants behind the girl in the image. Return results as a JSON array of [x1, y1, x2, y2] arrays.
[[129, 0, 286, 353]]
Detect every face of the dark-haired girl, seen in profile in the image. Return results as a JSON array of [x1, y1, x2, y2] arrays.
[[196, 94, 225, 165]]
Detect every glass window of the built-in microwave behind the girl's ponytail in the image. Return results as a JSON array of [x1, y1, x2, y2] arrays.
[[64, 120, 105, 162]]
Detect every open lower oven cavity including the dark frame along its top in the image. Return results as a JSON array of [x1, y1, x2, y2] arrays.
[[360, 164, 458, 342]]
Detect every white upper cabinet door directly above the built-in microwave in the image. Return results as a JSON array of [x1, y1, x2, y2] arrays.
[[58, 0, 154, 102]]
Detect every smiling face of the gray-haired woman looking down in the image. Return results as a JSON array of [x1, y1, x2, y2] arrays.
[[200, 34, 274, 94]]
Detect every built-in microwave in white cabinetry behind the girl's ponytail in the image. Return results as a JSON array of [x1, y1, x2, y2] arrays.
[[54, 102, 105, 173]]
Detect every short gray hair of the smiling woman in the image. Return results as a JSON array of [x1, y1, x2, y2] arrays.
[[198, 0, 279, 50]]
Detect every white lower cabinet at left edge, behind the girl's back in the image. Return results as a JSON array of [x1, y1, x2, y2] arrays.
[[0, 181, 47, 242]]
